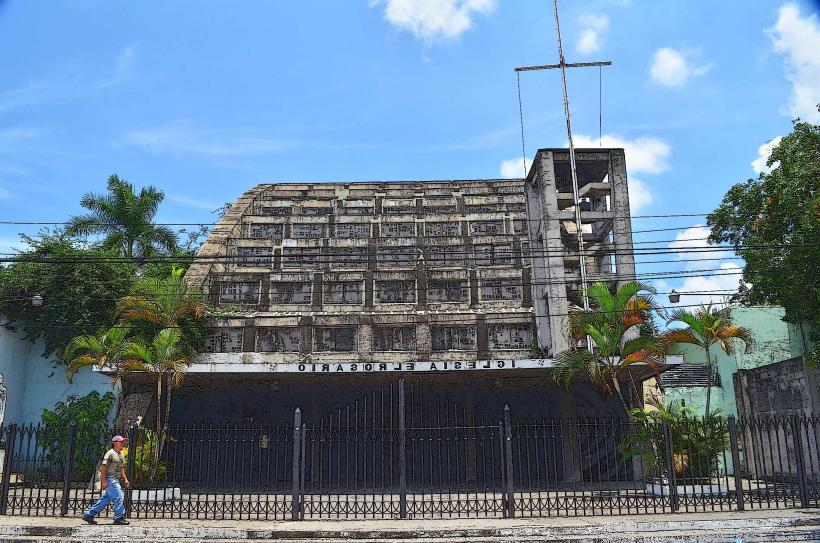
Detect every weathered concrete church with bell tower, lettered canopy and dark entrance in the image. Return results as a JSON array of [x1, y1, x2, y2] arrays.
[[155, 149, 660, 425]]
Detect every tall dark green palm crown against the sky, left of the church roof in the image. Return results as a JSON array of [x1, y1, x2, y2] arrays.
[[68, 175, 177, 258]]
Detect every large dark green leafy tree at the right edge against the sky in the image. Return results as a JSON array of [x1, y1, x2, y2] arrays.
[[707, 120, 820, 362]]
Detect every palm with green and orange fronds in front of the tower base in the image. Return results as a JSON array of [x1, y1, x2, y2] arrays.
[[552, 282, 663, 413]]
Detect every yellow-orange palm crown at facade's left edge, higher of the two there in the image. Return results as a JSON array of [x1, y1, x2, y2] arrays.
[[114, 267, 207, 357]]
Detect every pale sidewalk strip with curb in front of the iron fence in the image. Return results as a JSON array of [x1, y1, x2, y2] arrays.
[[0, 509, 820, 543]]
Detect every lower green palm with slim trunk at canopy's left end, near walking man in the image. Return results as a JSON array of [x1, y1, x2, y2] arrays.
[[114, 328, 190, 478]]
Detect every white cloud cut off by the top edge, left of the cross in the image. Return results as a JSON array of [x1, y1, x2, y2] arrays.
[[370, 0, 496, 43]]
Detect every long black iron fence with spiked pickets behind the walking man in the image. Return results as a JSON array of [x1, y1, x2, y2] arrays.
[[0, 382, 820, 519]]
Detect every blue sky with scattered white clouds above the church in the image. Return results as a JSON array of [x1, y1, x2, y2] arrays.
[[0, 0, 820, 300]]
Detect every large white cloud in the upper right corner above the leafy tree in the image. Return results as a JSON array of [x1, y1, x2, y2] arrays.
[[767, 3, 820, 123]]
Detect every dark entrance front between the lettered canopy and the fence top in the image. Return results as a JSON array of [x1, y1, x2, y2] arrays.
[[172, 370, 620, 427]]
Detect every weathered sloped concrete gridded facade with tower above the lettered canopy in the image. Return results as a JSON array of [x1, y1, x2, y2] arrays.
[[186, 149, 634, 371]]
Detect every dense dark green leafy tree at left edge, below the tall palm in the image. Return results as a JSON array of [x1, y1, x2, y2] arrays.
[[0, 231, 135, 356]]
